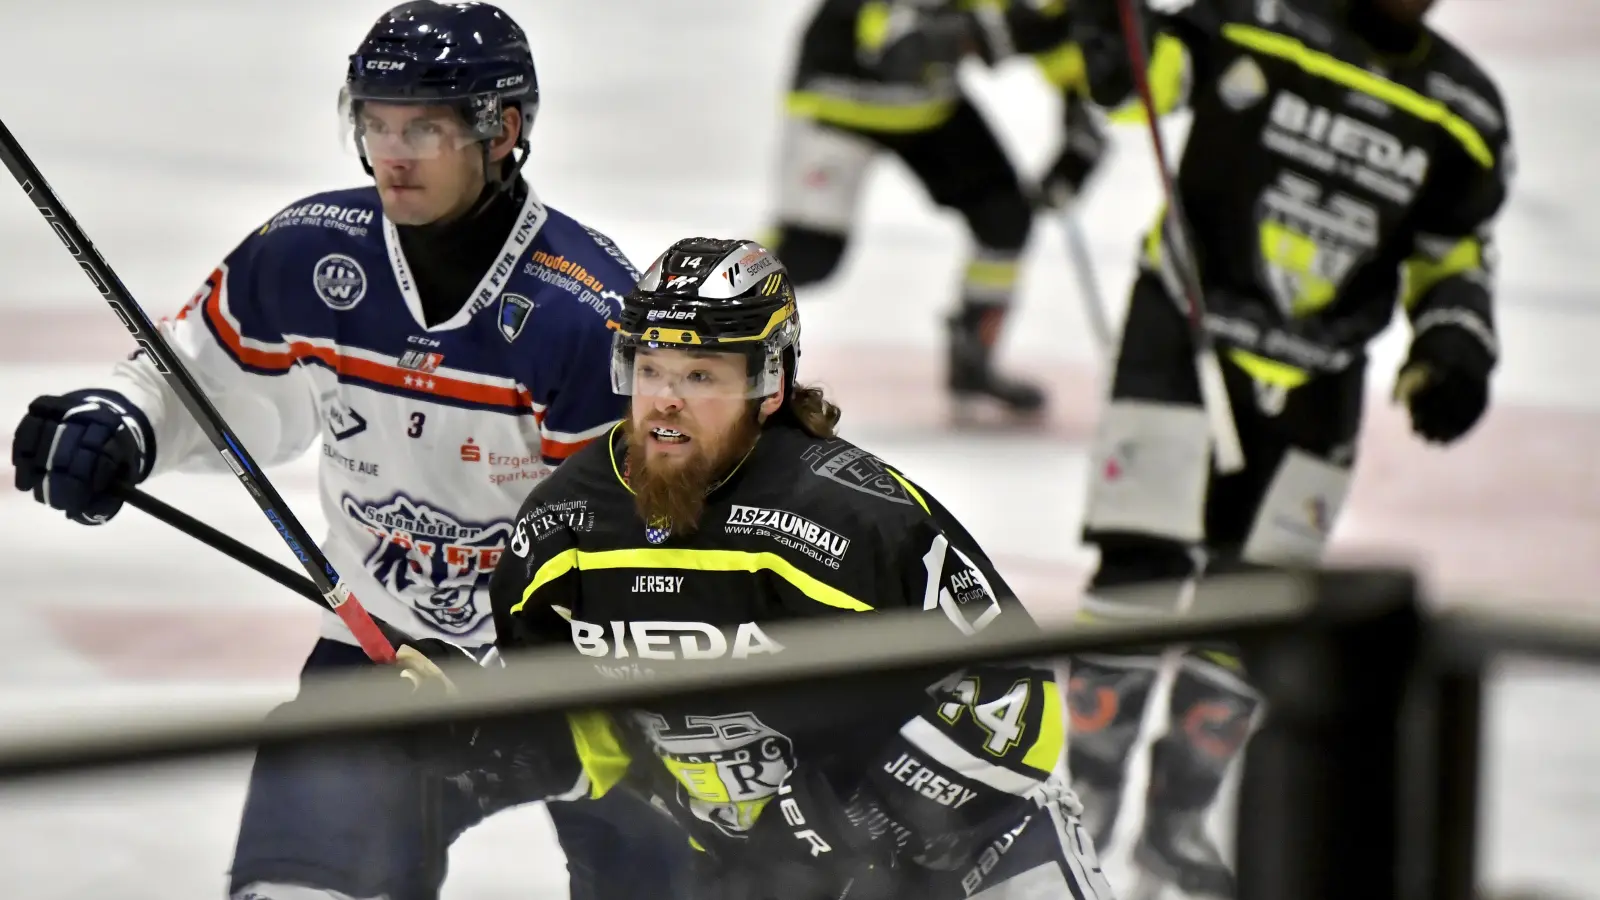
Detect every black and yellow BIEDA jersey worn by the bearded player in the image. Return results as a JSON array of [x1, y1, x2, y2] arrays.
[[491, 423, 1062, 858]]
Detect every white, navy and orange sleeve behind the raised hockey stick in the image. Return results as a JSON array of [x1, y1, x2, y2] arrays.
[[110, 212, 322, 472]]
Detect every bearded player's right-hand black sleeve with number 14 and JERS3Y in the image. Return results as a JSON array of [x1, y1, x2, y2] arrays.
[[858, 482, 1064, 865]]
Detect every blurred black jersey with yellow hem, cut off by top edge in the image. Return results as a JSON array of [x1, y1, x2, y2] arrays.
[[786, 0, 1082, 135]]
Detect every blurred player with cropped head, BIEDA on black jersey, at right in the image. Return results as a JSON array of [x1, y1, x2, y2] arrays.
[[1069, 0, 1512, 897]]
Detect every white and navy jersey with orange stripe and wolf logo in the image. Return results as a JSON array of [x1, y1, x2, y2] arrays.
[[110, 187, 637, 645]]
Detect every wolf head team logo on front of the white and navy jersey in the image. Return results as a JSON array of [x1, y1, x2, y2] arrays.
[[339, 493, 510, 634]]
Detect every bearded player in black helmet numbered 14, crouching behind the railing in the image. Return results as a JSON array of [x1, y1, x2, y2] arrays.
[[406, 239, 1107, 900]]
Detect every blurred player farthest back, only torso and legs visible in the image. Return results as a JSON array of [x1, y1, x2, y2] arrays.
[[770, 0, 1102, 413]]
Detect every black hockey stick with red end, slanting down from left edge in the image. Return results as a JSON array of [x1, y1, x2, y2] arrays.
[[0, 115, 395, 663]]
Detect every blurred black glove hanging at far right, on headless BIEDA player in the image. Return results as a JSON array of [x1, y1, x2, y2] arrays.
[[1395, 317, 1494, 444]]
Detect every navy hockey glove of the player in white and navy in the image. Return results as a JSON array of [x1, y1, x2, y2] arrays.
[[11, 391, 155, 525]]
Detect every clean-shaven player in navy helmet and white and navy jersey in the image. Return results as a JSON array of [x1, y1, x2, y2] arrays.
[[11, 0, 682, 900]]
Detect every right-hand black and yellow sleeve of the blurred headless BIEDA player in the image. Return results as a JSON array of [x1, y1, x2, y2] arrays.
[[1402, 74, 1514, 360]]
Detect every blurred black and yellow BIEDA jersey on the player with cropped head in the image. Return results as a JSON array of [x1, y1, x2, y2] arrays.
[[1075, 0, 1514, 388]]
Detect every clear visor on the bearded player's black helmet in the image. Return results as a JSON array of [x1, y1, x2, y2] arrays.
[[611, 335, 784, 400]]
